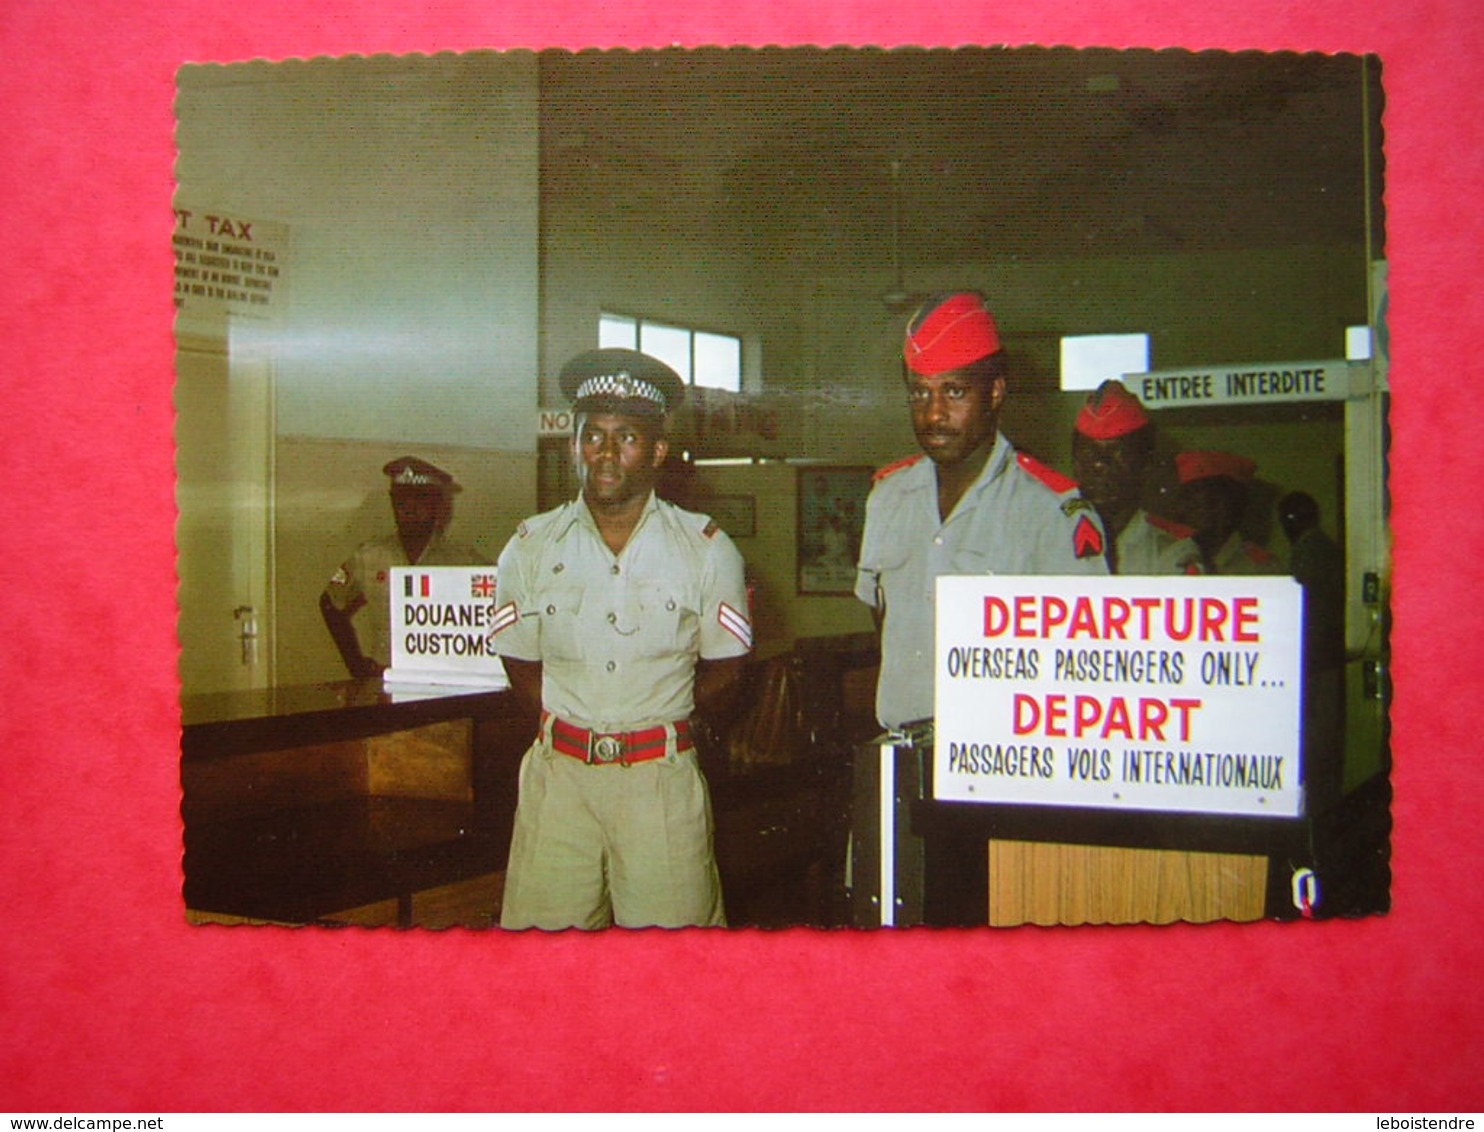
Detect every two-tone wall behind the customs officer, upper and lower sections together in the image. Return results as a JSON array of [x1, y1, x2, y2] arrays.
[[177, 52, 540, 687]]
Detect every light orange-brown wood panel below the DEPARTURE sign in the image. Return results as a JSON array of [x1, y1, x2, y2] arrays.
[[988, 840, 1267, 927]]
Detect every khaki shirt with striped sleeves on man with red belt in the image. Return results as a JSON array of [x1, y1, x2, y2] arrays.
[[494, 494, 752, 731]]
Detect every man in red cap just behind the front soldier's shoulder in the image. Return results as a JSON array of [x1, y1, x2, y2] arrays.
[[1071, 381, 1204, 576]]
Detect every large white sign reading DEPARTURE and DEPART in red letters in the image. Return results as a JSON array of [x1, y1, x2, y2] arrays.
[[933, 576, 1303, 817]]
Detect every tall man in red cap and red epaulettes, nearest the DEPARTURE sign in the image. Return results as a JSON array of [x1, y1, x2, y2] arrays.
[[855, 291, 1107, 728]]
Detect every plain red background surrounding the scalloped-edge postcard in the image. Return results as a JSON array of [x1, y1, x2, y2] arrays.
[[0, 0, 1484, 1113]]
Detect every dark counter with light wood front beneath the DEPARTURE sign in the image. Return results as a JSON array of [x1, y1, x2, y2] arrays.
[[852, 742, 1347, 927]]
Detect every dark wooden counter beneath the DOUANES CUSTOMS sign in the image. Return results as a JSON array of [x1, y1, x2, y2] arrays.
[[181, 679, 536, 926]]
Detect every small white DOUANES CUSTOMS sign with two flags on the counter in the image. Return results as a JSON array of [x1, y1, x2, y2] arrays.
[[383, 565, 509, 690]]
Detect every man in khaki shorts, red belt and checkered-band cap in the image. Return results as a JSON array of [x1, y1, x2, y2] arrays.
[[493, 349, 752, 929]]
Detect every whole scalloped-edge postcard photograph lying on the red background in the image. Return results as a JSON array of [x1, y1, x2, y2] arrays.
[[172, 47, 1391, 929]]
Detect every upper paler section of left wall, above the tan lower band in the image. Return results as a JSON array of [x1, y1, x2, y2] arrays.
[[177, 52, 539, 451]]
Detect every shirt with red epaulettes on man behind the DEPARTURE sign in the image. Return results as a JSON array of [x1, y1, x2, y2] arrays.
[[855, 435, 1107, 727]]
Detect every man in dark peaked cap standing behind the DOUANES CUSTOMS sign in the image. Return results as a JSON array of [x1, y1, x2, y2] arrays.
[[319, 455, 490, 678]]
